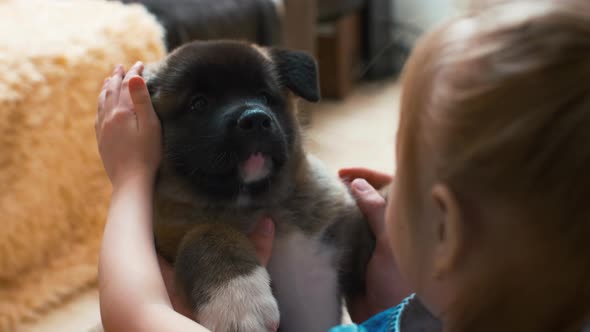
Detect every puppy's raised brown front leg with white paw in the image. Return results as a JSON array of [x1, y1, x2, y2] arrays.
[[174, 225, 279, 332]]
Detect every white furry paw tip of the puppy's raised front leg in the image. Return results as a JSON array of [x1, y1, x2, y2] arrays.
[[196, 267, 279, 332]]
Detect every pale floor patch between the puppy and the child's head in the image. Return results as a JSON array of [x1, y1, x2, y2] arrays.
[[307, 81, 400, 172]]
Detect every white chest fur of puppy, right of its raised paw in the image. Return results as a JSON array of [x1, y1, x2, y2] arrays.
[[267, 232, 342, 332]]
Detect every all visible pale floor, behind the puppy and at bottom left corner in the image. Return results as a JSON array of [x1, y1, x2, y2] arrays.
[[19, 77, 400, 332]]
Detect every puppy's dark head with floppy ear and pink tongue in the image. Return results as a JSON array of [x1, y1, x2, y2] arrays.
[[147, 41, 319, 201]]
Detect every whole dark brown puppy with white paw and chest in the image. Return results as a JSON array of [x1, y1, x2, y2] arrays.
[[144, 41, 374, 332]]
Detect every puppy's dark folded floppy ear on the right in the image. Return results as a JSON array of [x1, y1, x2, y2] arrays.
[[270, 48, 320, 102]]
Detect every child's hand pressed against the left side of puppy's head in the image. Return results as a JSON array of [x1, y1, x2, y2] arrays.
[[95, 62, 162, 188]]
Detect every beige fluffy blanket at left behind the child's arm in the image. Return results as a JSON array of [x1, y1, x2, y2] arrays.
[[0, 0, 165, 331]]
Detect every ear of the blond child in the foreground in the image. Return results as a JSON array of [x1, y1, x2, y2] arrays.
[[431, 183, 466, 277]]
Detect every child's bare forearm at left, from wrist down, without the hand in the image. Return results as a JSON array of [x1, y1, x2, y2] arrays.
[[99, 177, 206, 332]]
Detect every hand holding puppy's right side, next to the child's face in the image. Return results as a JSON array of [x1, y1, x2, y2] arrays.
[[339, 168, 410, 323]]
